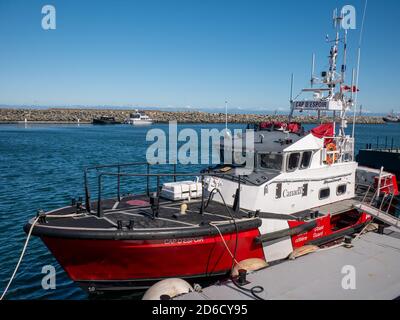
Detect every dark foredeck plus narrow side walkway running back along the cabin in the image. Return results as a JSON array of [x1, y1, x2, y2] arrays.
[[32, 195, 366, 231]]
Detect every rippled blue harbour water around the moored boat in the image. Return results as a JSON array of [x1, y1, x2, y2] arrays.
[[0, 124, 400, 299]]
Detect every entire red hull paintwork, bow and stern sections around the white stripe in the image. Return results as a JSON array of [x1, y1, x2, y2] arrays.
[[42, 212, 370, 289]]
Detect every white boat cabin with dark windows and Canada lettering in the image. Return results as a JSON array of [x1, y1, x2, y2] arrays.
[[207, 125, 357, 215]]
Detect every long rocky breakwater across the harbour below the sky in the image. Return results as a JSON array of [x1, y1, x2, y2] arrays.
[[0, 108, 384, 124]]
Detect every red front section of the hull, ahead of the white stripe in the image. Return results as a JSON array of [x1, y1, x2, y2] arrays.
[[42, 229, 264, 288]]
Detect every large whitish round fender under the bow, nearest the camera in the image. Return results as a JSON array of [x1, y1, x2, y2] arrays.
[[142, 278, 194, 300]]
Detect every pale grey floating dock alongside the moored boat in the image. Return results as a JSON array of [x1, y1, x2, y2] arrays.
[[176, 227, 400, 300]]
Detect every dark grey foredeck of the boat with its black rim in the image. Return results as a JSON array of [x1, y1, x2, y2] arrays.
[[25, 195, 261, 239]]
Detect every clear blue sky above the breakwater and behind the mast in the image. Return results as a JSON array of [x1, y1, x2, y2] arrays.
[[0, 0, 400, 112]]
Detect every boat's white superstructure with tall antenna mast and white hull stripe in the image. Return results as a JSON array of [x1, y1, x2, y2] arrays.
[[205, 10, 358, 261]]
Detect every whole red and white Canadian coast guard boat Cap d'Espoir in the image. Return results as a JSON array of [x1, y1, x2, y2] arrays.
[[25, 11, 398, 291]]
